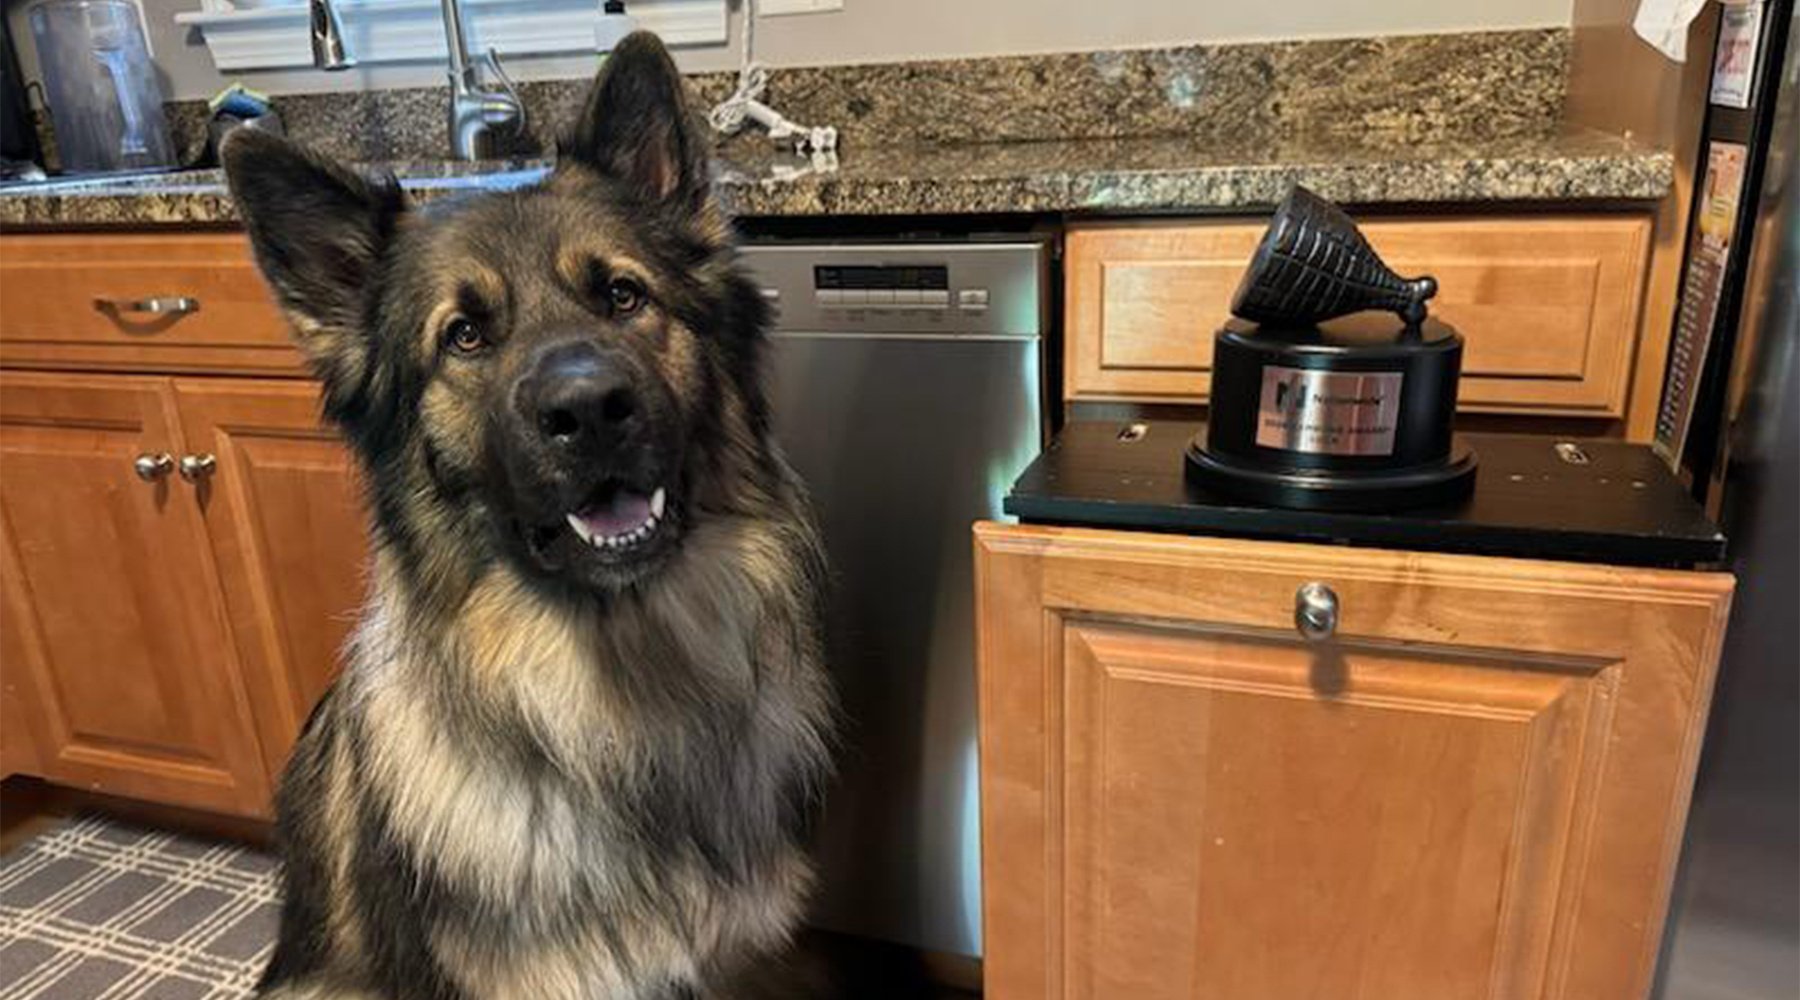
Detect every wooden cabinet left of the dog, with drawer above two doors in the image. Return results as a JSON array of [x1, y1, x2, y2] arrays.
[[0, 232, 367, 817]]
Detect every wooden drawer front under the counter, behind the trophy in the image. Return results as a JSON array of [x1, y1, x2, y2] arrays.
[[1066, 216, 1651, 417]]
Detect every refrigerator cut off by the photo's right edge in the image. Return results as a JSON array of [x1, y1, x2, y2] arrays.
[[1652, 5, 1800, 1000]]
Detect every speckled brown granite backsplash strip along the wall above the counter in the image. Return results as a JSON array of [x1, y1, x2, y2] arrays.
[[154, 29, 1570, 160]]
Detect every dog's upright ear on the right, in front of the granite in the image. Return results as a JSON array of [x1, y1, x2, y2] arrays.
[[562, 31, 707, 207]]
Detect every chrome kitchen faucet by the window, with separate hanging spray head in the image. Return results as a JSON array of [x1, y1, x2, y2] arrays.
[[308, 0, 526, 160]]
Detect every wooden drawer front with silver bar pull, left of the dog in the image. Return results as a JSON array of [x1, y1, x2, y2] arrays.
[[0, 234, 297, 367]]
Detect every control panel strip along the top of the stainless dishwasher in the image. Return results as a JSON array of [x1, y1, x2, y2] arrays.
[[743, 241, 1048, 336]]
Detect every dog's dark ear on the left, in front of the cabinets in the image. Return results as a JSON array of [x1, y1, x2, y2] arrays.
[[220, 128, 405, 394]]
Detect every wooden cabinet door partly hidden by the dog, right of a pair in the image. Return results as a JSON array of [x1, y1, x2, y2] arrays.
[[175, 379, 367, 777]]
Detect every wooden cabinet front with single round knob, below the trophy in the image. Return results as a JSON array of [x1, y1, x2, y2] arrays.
[[977, 525, 1730, 1000]]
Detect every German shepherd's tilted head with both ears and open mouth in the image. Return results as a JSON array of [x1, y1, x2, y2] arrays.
[[223, 34, 767, 590]]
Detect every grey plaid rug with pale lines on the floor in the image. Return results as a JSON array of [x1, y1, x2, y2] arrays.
[[0, 817, 279, 1000]]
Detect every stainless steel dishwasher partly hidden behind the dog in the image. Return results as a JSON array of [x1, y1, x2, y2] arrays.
[[745, 237, 1051, 955]]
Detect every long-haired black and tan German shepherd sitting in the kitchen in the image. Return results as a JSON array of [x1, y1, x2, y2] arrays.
[[223, 34, 833, 1000]]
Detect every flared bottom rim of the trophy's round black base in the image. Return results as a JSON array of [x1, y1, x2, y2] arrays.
[[1186, 435, 1476, 511]]
